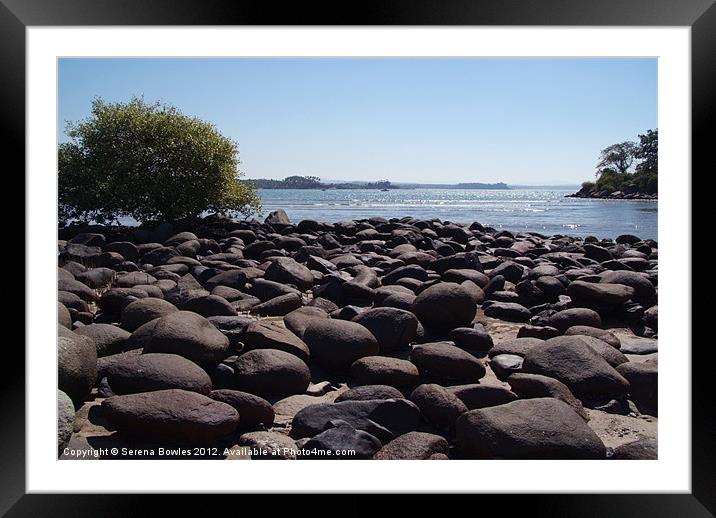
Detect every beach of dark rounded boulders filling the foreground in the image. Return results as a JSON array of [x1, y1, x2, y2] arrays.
[[57, 210, 658, 460]]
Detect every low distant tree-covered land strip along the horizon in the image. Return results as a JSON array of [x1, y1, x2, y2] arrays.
[[242, 176, 510, 190]]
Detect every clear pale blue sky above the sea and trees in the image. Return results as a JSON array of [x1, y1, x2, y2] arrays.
[[58, 58, 657, 185]]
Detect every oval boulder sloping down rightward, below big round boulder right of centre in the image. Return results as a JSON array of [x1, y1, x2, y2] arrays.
[[410, 343, 486, 382]]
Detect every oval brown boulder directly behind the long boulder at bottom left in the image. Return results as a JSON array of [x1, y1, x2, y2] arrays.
[[104, 353, 211, 394]]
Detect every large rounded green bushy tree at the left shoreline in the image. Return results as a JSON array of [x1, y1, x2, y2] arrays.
[[58, 98, 260, 223]]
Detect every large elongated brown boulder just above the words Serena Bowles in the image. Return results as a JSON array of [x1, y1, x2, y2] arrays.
[[101, 389, 239, 445]]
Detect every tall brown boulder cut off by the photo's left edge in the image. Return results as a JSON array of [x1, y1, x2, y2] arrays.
[[57, 336, 97, 404]]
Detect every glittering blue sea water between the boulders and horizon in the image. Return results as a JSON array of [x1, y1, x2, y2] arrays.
[[259, 189, 658, 239]]
